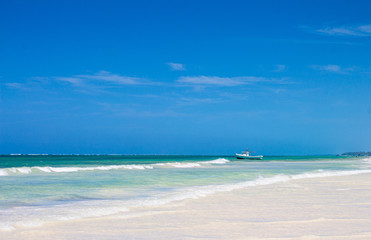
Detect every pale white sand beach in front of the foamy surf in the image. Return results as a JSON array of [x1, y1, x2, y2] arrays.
[[0, 173, 371, 240]]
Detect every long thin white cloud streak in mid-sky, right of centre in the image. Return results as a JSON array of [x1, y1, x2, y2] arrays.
[[177, 76, 289, 87]]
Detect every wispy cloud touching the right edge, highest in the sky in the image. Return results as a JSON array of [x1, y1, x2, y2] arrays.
[[316, 24, 371, 37]]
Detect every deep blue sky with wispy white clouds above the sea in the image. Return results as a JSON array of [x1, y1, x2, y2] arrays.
[[0, 0, 371, 155]]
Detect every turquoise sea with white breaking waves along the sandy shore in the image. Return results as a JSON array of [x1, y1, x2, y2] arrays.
[[0, 155, 371, 231]]
